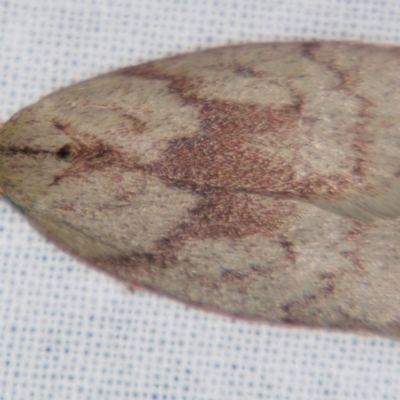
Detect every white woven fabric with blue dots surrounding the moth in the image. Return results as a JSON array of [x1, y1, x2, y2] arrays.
[[0, 0, 400, 400]]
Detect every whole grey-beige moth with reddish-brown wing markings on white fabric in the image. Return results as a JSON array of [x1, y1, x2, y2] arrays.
[[0, 42, 400, 337]]
